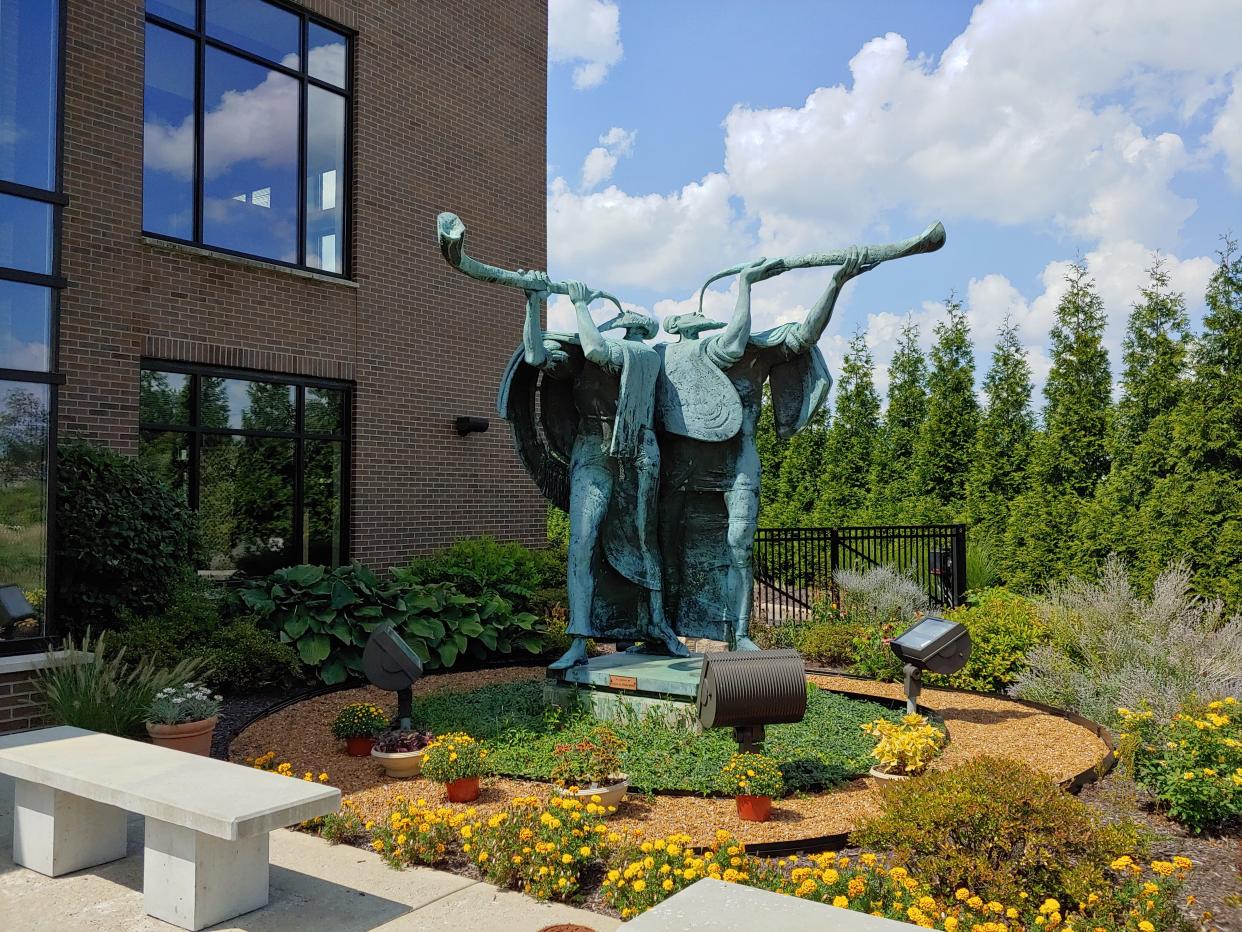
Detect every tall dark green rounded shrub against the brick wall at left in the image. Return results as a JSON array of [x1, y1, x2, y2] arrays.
[[56, 442, 199, 633]]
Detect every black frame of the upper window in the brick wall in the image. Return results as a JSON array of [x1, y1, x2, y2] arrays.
[[142, 0, 358, 281]]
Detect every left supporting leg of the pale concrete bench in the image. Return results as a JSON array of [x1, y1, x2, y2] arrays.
[[12, 780, 128, 877]]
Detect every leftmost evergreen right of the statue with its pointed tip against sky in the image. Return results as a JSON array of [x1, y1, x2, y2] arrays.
[[815, 333, 879, 527]]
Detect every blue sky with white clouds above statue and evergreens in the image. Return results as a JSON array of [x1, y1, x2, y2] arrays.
[[548, 0, 1242, 402]]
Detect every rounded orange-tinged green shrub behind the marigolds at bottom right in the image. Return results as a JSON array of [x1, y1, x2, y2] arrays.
[[851, 757, 1145, 903]]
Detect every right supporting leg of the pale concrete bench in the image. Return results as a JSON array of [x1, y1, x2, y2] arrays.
[[143, 818, 267, 930]]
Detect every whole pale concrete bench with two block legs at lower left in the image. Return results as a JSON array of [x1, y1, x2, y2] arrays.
[[0, 727, 340, 930]]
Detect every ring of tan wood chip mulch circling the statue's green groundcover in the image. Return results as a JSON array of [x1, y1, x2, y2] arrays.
[[230, 667, 1108, 844]]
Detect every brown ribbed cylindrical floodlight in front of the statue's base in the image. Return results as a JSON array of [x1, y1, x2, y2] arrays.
[[698, 650, 806, 753]]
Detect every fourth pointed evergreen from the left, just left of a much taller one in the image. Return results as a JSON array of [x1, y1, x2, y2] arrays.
[[966, 318, 1035, 541]]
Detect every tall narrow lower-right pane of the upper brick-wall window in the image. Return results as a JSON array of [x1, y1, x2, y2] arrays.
[[307, 87, 345, 272]]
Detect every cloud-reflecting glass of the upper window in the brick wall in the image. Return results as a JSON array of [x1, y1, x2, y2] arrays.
[[143, 0, 349, 275]]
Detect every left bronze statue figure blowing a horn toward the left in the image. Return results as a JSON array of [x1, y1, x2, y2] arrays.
[[438, 214, 688, 670]]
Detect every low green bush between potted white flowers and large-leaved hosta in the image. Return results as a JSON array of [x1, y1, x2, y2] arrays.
[[112, 578, 304, 692]]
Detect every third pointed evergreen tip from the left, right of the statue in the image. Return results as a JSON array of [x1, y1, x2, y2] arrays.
[[915, 295, 979, 518]]
